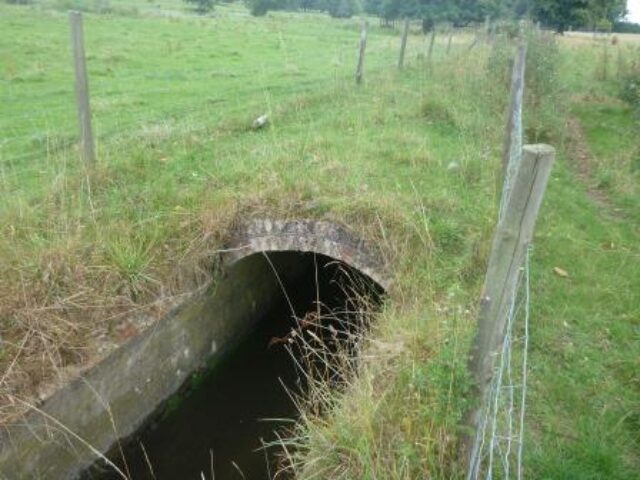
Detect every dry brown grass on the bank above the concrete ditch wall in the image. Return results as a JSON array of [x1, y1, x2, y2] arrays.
[[0, 206, 235, 423]]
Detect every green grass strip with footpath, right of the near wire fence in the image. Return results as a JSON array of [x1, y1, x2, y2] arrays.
[[528, 36, 640, 479]]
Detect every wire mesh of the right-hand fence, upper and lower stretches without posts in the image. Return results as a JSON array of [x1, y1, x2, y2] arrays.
[[467, 32, 532, 480]]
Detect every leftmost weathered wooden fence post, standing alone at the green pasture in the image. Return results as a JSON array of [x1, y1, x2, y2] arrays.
[[69, 12, 96, 167]]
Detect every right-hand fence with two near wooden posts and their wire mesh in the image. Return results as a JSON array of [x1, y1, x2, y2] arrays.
[[460, 29, 555, 480]]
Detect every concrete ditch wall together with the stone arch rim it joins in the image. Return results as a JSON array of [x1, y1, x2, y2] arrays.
[[0, 221, 388, 480]]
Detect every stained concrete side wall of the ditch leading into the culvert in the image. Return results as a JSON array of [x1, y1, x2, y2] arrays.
[[0, 255, 302, 480]]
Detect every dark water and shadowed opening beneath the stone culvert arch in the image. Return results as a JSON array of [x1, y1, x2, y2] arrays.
[[83, 252, 383, 480]]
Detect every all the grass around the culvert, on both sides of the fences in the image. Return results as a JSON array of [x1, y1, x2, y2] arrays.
[[0, 2, 640, 479]]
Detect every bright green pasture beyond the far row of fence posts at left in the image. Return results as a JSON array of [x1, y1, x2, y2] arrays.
[[0, 5, 400, 183]]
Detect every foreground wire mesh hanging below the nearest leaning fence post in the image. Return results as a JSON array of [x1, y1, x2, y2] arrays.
[[467, 247, 532, 480]]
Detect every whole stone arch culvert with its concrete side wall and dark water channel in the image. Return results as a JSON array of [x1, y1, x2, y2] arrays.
[[0, 220, 390, 480]]
